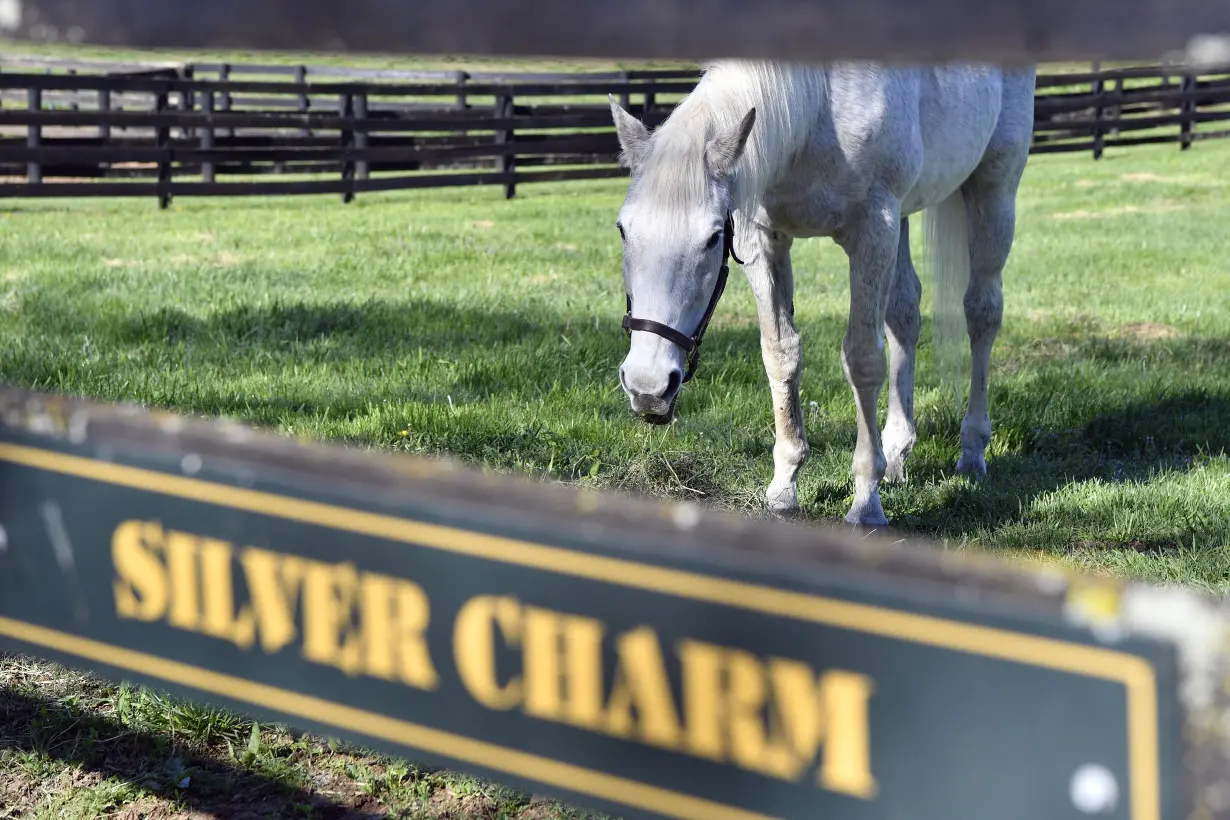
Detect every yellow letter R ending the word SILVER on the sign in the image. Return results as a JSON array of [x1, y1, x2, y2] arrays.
[[359, 573, 439, 690]]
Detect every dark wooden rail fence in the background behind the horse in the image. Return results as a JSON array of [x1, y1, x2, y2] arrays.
[[0, 60, 1230, 207]]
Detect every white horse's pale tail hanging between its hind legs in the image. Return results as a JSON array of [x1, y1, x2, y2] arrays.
[[923, 188, 969, 414]]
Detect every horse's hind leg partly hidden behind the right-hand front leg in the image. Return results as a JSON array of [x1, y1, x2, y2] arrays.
[[882, 219, 923, 482]]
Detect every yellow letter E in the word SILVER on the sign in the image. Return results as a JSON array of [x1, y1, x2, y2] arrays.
[[303, 561, 363, 675]]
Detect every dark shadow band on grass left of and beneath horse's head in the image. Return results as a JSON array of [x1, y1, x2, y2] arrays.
[[5, 296, 852, 429]]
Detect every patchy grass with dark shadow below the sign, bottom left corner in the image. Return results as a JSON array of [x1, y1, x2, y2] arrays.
[[0, 655, 589, 820]]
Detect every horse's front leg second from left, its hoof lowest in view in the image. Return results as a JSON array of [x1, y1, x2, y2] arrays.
[[839, 198, 902, 526]]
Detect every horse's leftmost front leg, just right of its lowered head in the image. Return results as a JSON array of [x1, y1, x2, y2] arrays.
[[743, 226, 808, 515]]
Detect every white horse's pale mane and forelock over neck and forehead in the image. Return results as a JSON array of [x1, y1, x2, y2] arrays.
[[642, 60, 828, 213]]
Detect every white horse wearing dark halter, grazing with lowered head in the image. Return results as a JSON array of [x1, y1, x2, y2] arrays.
[[610, 60, 1034, 526]]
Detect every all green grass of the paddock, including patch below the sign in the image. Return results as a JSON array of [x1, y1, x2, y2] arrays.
[[0, 116, 1230, 820]]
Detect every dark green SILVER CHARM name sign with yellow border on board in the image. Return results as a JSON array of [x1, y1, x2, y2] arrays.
[[0, 433, 1180, 820]]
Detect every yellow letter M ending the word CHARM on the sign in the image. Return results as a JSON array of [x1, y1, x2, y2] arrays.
[[769, 659, 877, 799]]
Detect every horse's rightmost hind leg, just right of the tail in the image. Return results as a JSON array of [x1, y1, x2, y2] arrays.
[[957, 168, 1020, 478]]
